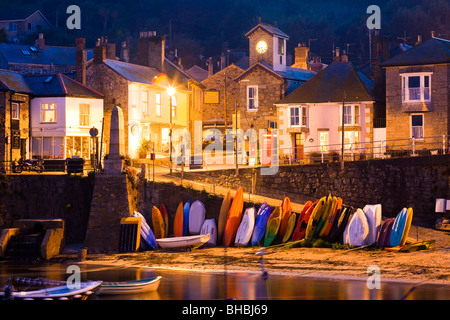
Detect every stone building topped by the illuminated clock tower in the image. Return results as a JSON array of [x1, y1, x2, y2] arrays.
[[202, 19, 315, 136]]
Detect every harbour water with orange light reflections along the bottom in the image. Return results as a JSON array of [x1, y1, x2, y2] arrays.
[[0, 262, 450, 300]]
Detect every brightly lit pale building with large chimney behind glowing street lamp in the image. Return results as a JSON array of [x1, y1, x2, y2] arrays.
[[85, 31, 203, 158]]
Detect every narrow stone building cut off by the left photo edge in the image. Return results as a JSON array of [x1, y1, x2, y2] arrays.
[[0, 70, 32, 172]]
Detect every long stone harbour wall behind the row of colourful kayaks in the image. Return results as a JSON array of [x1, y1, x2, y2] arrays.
[[180, 155, 450, 226]]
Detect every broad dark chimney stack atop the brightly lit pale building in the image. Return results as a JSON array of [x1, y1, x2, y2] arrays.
[[138, 31, 166, 72]]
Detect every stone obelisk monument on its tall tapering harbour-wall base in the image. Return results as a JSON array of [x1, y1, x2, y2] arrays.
[[84, 107, 136, 253]]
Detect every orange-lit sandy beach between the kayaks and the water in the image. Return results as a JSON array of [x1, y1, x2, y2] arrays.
[[65, 226, 450, 284]]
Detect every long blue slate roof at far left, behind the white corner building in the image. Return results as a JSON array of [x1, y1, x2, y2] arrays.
[[0, 43, 94, 67]]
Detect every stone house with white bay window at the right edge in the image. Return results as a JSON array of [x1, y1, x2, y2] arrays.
[[381, 37, 450, 150]]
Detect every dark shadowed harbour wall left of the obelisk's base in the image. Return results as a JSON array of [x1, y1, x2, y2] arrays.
[[0, 174, 94, 243]]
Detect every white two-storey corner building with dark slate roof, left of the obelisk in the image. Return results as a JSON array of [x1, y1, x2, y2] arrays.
[[26, 74, 103, 160]]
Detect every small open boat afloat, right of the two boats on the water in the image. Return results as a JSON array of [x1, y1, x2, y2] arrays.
[[97, 276, 161, 295]]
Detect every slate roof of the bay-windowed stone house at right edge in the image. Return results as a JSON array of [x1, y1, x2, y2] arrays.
[[381, 37, 450, 67]]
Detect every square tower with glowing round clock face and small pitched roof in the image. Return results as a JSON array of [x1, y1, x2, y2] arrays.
[[245, 18, 289, 71]]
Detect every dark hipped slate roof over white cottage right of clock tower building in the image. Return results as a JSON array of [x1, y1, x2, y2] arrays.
[[277, 62, 374, 104]]
